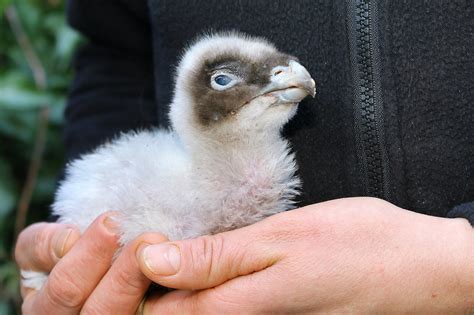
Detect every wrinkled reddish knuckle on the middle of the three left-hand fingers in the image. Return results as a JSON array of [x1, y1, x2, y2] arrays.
[[46, 269, 87, 309]]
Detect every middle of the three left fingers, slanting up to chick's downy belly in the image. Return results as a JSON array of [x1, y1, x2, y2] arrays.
[[24, 213, 118, 314]]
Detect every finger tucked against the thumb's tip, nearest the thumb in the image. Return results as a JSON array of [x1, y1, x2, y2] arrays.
[[82, 233, 167, 314]]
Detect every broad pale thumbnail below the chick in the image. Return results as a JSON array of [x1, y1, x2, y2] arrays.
[[141, 244, 181, 276]]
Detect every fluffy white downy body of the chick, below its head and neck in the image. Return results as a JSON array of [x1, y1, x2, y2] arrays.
[[53, 130, 299, 243]]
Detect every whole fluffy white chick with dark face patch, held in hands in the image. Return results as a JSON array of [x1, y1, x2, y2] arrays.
[[23, 33, 315, 288]]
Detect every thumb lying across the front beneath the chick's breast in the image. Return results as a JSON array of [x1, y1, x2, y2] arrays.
[[137, 224, 280, 290]]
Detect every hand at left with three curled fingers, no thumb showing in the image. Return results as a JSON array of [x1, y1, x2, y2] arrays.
[[15, 213, 165, 315]]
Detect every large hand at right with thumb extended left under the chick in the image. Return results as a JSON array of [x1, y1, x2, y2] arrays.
[[137, 198, 474, 314]]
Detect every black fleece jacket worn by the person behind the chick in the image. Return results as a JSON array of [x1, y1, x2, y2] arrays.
[[65, 0, 474, 223]]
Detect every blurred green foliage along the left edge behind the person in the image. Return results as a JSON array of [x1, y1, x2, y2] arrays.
[[0, 0, 80, 314]]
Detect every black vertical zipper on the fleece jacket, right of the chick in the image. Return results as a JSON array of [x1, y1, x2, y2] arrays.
[[347, 0, 390, 200]]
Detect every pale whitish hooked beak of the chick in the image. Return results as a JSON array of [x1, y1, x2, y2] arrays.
[[262, 60, 316, 103]]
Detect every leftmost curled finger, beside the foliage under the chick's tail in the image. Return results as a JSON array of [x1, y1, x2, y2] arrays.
[[15, 223, 80, 272]]
